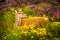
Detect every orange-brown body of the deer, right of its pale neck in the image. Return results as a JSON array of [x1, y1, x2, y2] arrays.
[[21, 17, 48, 26]]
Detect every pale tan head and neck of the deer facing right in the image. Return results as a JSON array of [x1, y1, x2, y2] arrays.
[[15, 9, 27, 26]]
